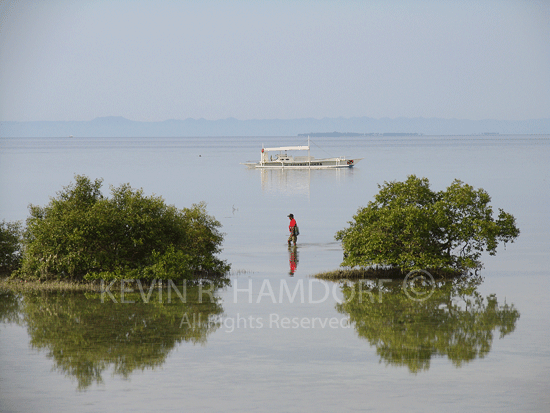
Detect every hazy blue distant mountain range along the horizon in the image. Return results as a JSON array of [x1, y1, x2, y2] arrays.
[[0, 116, 550, 138]]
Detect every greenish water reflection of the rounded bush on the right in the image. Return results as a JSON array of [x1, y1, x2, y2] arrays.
[[336, 279, 520, 373]]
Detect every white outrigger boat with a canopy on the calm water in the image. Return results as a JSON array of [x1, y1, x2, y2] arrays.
[[242, 138, 363, 169]]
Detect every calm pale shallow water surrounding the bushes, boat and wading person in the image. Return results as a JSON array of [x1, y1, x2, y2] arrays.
[[0, 136, 550, 411]]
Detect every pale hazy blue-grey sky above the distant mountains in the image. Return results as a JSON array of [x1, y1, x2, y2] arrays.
[[0, 0, 550, 121]]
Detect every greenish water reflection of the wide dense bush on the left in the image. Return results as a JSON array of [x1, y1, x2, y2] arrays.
[[16, 287, 223, 390]]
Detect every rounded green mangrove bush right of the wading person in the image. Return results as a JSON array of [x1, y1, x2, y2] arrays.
[[336, 175, 519, 272]]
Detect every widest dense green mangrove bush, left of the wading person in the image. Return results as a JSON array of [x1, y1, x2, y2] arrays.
[[17, 175, 229, 281]]
